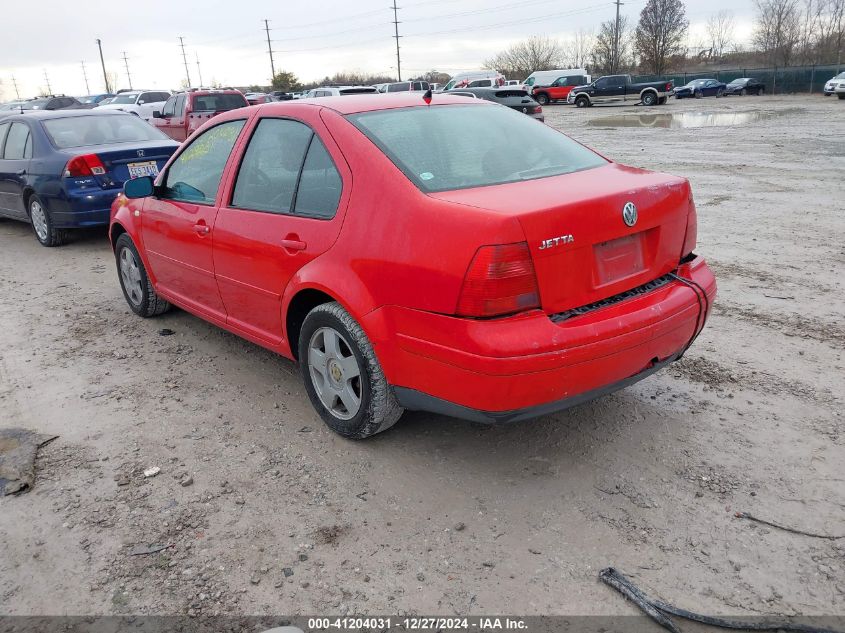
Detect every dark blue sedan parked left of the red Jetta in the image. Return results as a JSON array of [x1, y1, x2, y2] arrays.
[[0, 110, 179, 246]]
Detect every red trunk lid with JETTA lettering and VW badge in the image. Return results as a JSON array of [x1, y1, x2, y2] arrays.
[[431, 163, 690, 314]]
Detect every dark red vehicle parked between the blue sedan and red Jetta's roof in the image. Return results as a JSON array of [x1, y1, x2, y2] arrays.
[[150, 90, 249, 141]]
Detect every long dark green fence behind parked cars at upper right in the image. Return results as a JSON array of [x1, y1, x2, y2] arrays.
[[634, 64, 845, 94]]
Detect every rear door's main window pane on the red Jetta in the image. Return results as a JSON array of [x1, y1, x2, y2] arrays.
[[232, 119, 313, 213]]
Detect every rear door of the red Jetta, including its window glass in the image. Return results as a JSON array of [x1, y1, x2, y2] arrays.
[[214, 108, 351, 346]]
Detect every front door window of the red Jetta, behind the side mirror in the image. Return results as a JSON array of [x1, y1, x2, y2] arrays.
[[161, 119, 245, 204]]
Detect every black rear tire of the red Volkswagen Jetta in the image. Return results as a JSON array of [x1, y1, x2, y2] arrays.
[[298, 301, 404, 440]]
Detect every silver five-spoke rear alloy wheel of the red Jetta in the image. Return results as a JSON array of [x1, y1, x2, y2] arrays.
[[308, 327, 362, 420]]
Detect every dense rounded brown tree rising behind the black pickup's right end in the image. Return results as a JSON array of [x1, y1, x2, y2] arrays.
[[634, 0, 689, 75]]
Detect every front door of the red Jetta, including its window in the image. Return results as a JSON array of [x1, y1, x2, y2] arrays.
[[141, 119, 246, 322]]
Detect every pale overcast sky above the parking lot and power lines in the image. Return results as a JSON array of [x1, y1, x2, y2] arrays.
[[0, 0, 753, 100]]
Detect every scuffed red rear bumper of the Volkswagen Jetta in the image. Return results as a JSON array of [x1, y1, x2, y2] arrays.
[[364, 258, 716, 422]]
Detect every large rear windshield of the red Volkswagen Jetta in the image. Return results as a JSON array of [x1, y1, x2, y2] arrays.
[[348, 104, 607, 192]]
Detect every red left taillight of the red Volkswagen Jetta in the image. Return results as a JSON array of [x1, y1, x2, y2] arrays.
[[457, 242, 540, 317]]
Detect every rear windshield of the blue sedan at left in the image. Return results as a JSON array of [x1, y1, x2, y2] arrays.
[[41, 114, 169, 149]]
